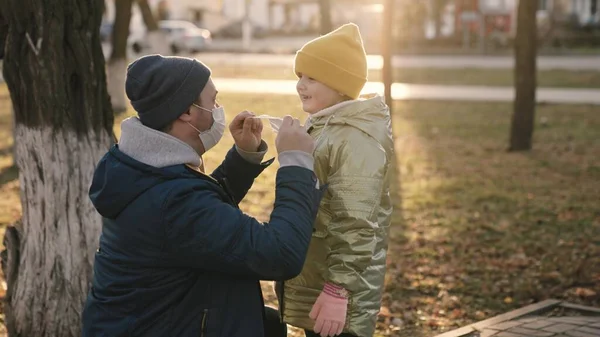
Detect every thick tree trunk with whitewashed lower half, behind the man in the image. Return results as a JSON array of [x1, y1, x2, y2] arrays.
[[0, 0, 114, 337]]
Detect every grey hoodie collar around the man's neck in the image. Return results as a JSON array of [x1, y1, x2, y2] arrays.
[[119, 117, 202, 168]]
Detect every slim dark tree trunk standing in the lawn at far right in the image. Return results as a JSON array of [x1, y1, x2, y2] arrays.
[[509, 0, 538, 151]]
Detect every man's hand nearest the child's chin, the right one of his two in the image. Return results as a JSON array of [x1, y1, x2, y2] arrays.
[[275, 116, 315, 155]]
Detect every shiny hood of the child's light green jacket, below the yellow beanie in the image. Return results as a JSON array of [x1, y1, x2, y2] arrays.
[[310, 95, 394, 150]]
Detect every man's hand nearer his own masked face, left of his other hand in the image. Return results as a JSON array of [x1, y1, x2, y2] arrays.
[[229, 111, 263, 152]]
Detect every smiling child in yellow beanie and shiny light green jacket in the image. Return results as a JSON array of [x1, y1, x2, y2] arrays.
[[276, 24, 394, 337]]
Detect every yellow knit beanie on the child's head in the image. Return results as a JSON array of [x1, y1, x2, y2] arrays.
[[294, 23, 367, 99]]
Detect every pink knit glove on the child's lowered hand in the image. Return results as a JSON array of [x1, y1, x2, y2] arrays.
[[309, 283, 348, 337]]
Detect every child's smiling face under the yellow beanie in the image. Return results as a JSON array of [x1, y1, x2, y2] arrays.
[[296, 74, 344, 114]]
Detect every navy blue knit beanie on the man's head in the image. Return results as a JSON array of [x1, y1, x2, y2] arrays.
[[125, 55, 210, 130]]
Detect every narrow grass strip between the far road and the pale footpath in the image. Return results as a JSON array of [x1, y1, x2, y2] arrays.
[[212, 66, 600, 88]]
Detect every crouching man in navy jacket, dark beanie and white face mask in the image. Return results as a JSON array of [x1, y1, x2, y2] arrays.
[[83, 55, 322, 337]]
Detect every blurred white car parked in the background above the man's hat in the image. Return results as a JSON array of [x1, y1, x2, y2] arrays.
[[128, 20, 212, 54]]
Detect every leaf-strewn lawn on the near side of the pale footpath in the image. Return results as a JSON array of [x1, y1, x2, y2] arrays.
[[0, 83, 600, 337]]
